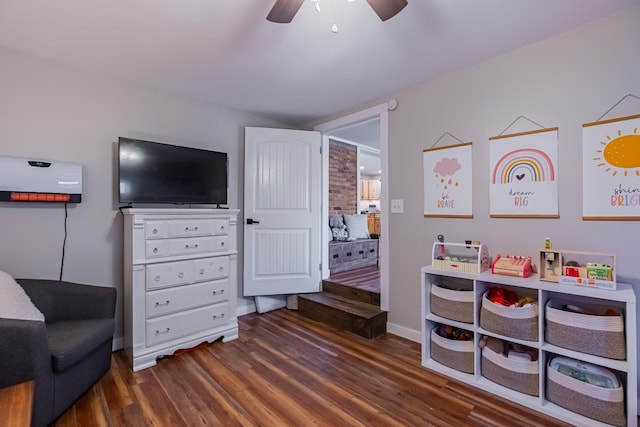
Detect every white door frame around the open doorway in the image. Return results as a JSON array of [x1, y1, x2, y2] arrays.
[[313, 103, 390, 311]]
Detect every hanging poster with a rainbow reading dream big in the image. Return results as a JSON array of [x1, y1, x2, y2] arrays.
[[489, 128, 558, 218]]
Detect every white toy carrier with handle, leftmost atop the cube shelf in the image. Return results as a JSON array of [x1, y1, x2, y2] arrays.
[[431, 241, 489, 274]]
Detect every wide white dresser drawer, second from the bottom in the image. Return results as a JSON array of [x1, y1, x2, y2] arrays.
[[145, 280, 229, 318]]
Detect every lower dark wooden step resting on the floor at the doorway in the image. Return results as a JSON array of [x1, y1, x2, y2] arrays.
[[298, 292, 387, 339]]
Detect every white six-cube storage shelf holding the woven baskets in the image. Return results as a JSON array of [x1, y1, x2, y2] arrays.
[[421, 266, 638, 427]]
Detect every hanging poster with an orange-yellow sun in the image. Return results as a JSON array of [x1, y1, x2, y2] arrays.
[[582, 115, 640, 220]]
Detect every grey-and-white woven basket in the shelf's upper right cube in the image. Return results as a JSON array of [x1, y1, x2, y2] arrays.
[[545, 300, 627, 360]]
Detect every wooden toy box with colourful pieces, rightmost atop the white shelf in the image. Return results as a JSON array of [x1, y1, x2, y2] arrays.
[[539, 249, 616, 290]]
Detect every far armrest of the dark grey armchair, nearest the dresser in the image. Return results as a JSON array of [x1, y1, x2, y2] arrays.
[[16, 279, 116, 323]]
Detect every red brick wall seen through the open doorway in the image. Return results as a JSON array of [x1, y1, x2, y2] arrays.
[[329, 140, 358, 216]]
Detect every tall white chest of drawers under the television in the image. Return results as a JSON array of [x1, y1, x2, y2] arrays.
[[122, 208, 238, 371]]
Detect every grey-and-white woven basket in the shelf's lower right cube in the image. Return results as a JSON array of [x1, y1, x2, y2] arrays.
[[547, 368, 624, 426]]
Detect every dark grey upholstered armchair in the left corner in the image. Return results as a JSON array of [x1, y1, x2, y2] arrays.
[[0, 279, 116, 427]]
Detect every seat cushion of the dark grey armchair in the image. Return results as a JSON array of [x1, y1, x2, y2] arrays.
[[47, 319, 115, 372]]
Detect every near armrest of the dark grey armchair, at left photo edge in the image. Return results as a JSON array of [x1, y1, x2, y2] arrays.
[[0, 319, 51, 387]]
